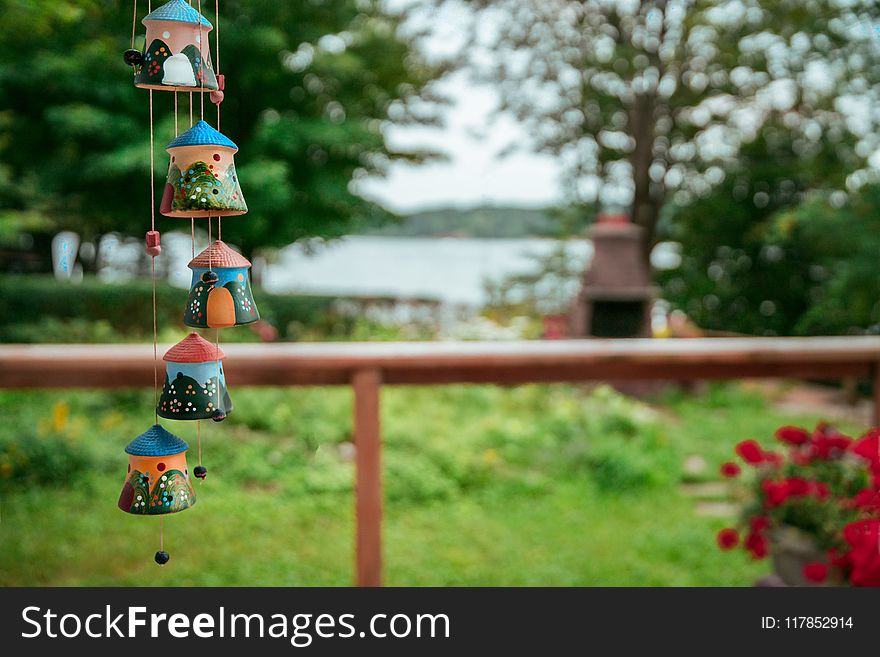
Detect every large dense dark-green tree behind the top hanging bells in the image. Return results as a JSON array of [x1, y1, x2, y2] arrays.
[[0, 0, 440, 262]]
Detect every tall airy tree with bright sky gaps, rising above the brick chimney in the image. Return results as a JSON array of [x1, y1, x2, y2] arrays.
[[450, 0, 880, 254]]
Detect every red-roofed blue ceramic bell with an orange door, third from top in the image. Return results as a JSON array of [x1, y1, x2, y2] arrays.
[[183, 240, 260, 328]]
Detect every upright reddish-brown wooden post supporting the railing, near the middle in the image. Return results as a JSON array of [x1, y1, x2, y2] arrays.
[[351, 369, 382, 586]]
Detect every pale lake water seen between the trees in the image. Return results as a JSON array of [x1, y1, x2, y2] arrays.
[[96, 233, 678, 306]]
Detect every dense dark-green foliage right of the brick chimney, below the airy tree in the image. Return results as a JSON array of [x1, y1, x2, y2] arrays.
[[660, 130, 880, 335]]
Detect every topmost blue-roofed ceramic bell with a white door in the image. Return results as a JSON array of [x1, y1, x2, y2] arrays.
[[133, 0, 219, 92]]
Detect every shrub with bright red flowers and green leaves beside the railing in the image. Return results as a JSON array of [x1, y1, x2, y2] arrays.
[[717, 424, 880, 586]]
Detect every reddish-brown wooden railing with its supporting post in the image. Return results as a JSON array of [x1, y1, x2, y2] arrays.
[[0, 337, 880, 586]]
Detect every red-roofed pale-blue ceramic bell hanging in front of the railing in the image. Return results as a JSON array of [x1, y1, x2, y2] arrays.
[[156, 332, 232, 422]]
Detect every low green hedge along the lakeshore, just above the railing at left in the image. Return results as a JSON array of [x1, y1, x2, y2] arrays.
[[0, 276, 334, 342]]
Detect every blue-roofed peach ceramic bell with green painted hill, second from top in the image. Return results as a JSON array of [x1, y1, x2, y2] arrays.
[[159, 121, 247, 219]]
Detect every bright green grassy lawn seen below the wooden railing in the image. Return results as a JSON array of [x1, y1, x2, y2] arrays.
[[0, 385, 860, 586]]
